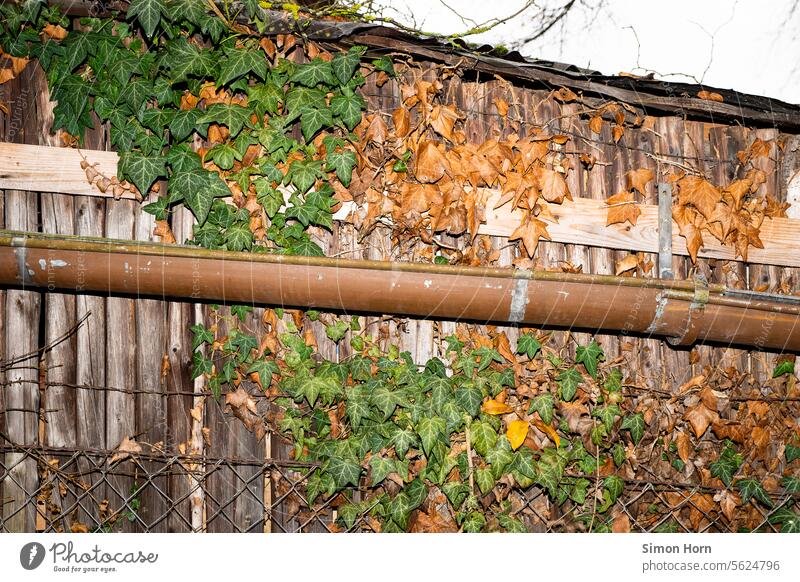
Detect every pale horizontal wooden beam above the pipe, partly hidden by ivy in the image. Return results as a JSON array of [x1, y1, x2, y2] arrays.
[[0, 143, 800, 267]]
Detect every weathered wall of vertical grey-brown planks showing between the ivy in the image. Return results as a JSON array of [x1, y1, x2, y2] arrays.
[[0, 57, 800, 532]]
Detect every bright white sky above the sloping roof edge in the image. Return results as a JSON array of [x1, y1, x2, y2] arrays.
[[384, 0, 800, 103]]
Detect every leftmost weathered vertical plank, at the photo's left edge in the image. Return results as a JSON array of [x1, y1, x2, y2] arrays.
[[3, 66, 46, 532]]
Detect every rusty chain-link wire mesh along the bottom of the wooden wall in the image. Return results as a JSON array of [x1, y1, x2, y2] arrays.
[[0, 443, 793, 533]]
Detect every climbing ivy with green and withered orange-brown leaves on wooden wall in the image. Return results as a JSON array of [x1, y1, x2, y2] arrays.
[[0, 0, 800, 532]]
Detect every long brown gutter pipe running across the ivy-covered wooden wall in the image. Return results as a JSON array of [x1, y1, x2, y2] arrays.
[[0, 231, 800, 351]]
